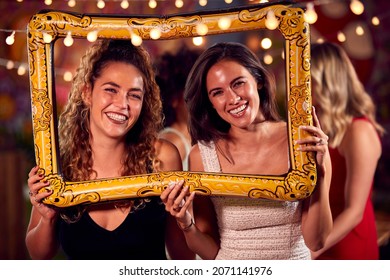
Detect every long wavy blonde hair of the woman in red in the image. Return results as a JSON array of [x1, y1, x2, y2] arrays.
[[310, 42, 384, 147]]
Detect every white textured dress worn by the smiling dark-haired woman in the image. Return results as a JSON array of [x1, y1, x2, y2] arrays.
[[198, 142, 310, 260]]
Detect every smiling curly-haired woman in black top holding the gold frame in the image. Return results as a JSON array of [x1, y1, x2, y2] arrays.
[[26, 40, 193, 259]]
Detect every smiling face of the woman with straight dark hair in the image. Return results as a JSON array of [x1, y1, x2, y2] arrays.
[[206, 60, 264, 128]]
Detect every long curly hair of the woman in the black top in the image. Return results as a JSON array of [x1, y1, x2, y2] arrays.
[[59, 39, 162, 220]]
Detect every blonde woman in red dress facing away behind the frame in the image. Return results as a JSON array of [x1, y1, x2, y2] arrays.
[[311, 43, 384, 259]]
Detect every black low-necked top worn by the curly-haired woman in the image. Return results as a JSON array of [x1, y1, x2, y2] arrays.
[[58, 197, 167, 260]]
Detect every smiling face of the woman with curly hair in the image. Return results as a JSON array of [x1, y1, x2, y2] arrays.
[[85, 62, 144, 140]]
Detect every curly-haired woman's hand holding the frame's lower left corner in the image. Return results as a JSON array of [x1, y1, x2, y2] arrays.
[[27, 166, 58, 220]]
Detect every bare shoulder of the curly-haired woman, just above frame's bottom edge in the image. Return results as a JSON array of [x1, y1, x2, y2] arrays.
[[154, 139, 183, 171]]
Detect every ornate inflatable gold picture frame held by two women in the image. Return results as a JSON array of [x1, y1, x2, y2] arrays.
[[28, 3, 317, 207]]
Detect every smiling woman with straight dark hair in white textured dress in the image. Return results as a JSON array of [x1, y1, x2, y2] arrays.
[[161, 43, 332, 259]]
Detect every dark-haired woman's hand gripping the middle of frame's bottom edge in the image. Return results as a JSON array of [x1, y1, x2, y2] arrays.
[[160, 180, 195, 229]]
